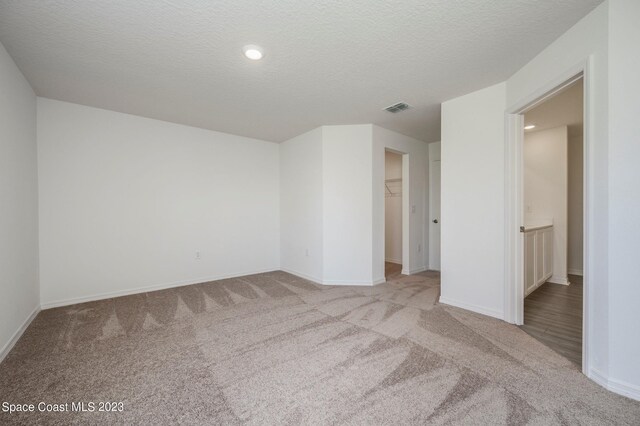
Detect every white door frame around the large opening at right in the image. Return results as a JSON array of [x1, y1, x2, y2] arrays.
[[504, 57, 594, 374]]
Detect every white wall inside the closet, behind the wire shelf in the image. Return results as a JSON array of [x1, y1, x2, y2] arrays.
[[384, 151, 402, 264]]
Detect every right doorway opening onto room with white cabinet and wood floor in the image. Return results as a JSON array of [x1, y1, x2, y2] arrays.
[[521, 78, 584, 366]]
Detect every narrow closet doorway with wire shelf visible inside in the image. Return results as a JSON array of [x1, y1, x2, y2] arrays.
[[384, 150, 403, 281]]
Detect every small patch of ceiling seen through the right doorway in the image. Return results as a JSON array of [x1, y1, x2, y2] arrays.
[[524, 79, 584, 136]]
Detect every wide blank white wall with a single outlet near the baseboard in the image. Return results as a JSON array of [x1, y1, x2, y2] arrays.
[[38, 98, 280, 306]]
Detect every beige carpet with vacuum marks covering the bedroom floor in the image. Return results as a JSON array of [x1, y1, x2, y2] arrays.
[[0, 272, 640, 425]]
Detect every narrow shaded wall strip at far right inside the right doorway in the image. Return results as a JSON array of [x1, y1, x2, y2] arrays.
[[567, 131, 584, 275]]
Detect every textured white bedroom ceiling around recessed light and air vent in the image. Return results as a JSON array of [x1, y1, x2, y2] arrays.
[[0, 0, 601, 142]]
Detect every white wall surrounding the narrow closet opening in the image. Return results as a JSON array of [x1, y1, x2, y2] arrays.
[[370, 125, 429, 282]]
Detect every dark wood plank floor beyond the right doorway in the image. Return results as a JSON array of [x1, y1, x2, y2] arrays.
[[521, 275, 582, 366]]
